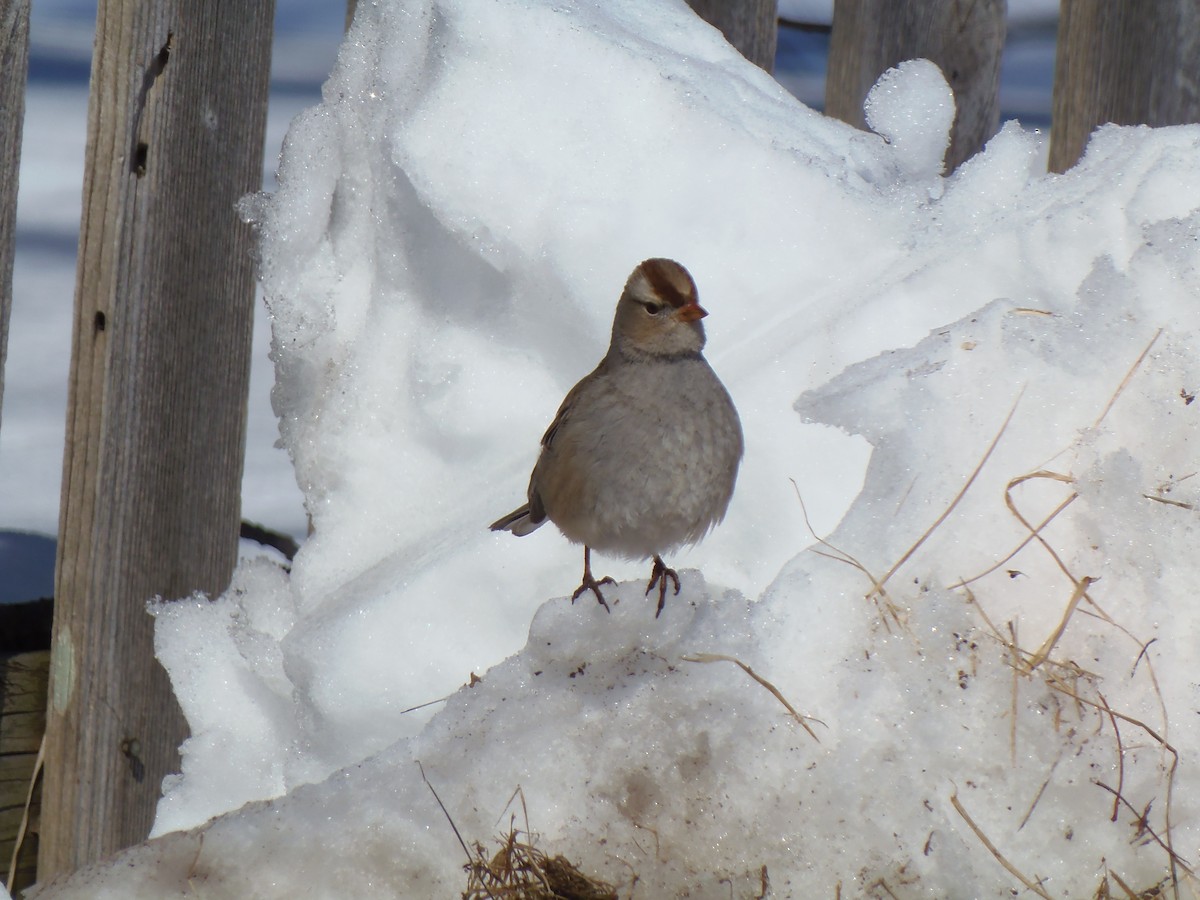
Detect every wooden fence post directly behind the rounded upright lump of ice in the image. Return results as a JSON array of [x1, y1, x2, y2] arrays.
[[826, 0, 1008, 172]]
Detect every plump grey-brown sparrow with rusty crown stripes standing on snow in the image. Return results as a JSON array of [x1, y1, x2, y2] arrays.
[[491, 258, 744, 618]]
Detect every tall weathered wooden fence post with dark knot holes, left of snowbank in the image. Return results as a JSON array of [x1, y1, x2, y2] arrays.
[[38, 0, 275, 880]]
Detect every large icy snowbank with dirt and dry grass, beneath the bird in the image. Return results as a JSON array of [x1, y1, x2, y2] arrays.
[[32, 0, 1200, 898]]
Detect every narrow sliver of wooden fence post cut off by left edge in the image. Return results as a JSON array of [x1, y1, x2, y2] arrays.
[[0, 0, 29, 429]]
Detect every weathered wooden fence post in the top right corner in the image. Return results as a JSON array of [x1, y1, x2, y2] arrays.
[[1050, 0, 1200, 172]]
